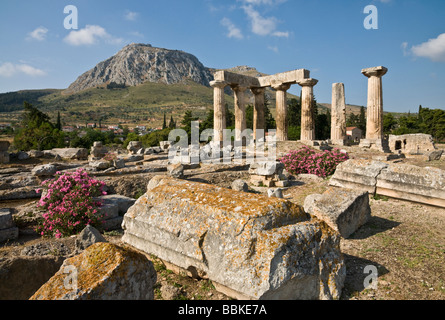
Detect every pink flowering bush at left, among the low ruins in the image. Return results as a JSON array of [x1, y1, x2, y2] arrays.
[[36, 169, 106, 238]]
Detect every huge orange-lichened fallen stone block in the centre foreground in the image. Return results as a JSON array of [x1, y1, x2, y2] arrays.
[[122, 176, 345, 299]]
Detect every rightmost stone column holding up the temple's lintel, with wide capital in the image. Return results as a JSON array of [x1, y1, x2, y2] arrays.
[[298, 78, 318, 141]]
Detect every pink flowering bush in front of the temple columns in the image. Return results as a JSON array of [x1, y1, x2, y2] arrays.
[[280, 146, 349, 178]]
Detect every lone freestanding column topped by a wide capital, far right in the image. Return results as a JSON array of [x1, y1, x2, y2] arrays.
[[362, 66, 388, 140]]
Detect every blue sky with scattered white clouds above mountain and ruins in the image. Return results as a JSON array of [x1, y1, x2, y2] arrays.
[[0, 0, 445, 112]]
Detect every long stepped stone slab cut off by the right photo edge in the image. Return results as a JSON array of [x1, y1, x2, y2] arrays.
[[376, 164, 445, 208]]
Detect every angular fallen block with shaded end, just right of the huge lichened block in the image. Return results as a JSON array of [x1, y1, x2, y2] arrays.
[[304, 188, 371, 238]]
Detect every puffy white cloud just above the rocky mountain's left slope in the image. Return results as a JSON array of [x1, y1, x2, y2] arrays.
[[64, 25, 123, 46]]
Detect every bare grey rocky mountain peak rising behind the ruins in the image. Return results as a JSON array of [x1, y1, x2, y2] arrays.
[[66, 43, 213, 93]]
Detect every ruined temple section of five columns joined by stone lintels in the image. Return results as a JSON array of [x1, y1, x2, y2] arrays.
[[210, 69, 318, 142]]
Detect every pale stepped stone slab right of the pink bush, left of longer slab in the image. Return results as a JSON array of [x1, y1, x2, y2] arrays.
[[329, 159, 388, 194]]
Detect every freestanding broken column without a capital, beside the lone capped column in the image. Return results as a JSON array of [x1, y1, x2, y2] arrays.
[[331, 83, 346, 145]]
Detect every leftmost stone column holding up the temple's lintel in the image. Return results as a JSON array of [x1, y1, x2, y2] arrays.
[[210, 80, 227, 142]]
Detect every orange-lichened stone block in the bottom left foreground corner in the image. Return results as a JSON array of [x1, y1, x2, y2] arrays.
[[30, 242, 156, 300]]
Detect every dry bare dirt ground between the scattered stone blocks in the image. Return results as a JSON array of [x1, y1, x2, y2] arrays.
[[0, 142, 445, 300]]
